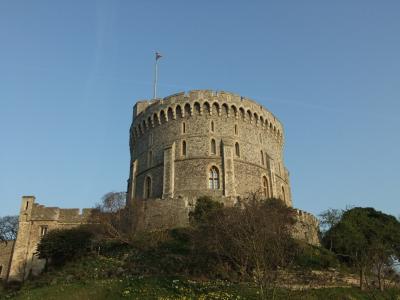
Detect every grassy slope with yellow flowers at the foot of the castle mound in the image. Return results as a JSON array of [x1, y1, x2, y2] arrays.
[[0, 256, 400, 300]]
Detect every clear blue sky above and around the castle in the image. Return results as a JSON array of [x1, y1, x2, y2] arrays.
[[0, 0, 400, 216]]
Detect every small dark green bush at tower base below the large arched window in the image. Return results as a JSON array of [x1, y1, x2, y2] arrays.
[[189, 196, 224, 225]]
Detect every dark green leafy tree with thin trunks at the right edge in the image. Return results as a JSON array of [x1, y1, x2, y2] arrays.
[[323, 207, 400, 290]]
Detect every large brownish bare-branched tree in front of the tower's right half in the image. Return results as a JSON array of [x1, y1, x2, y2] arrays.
[[192, 194, 297, 298]]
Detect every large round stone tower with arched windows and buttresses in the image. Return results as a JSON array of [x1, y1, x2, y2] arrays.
[[128, 90, 292, 206]]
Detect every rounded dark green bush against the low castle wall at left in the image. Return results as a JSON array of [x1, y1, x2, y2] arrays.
[[37, 227, 93, 266]]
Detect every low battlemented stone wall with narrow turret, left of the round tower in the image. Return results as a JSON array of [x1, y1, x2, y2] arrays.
[[8, 196, 91, 281]]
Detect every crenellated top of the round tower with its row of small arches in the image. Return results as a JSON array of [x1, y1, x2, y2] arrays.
[[130, 90, 284, 147]]
